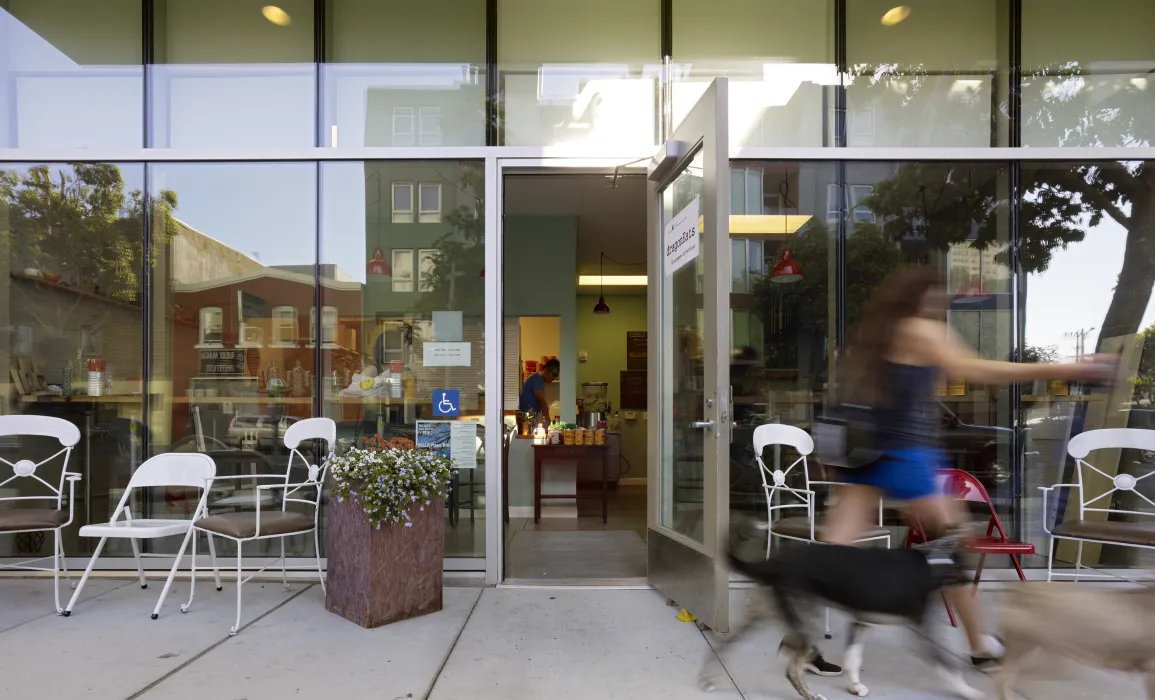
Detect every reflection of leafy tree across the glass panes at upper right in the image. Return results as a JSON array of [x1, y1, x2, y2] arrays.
[[851, 61, 1155, 349]]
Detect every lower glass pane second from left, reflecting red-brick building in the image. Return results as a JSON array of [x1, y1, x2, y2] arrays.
[[149, 163, 325, 556]]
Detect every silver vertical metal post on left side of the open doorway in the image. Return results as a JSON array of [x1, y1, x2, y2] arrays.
[[483, 157, 505, 586]]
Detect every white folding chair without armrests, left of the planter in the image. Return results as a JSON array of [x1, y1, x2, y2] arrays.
[[65, 452, 221, 620]]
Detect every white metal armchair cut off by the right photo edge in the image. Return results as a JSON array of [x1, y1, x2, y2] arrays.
[[1040, 427, 1155, 581]]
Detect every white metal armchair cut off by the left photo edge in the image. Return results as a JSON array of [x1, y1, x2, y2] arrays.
[[0, 416, 81, 615]]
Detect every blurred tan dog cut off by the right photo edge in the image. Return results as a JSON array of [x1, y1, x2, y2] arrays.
[[994, 583, 1155, 700]]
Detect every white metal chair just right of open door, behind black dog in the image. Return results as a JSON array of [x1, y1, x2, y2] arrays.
[[753, 423, 891, 639]]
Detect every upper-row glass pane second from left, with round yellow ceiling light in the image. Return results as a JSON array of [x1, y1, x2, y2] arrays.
[[148, 0, 316, 148]]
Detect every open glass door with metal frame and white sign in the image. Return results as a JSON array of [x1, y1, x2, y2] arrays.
[[647, 79, 731, 632]]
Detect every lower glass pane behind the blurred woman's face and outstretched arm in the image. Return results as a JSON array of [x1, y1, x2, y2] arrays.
[[845, 162, 1018, 527]]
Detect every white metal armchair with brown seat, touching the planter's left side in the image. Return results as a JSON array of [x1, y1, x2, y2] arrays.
[[193, 418, 337, 635]]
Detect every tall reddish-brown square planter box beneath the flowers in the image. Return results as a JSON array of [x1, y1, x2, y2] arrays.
[[325, 499, 445, 627]]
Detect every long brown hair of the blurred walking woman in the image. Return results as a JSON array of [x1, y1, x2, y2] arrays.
[[842, 265, 941, 405]]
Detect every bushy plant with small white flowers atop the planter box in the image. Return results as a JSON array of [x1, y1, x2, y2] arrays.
[[329, 435, 457, 530]]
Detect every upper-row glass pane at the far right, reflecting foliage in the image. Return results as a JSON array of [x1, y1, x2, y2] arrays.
[[1022, 0, 1155, 146]]
